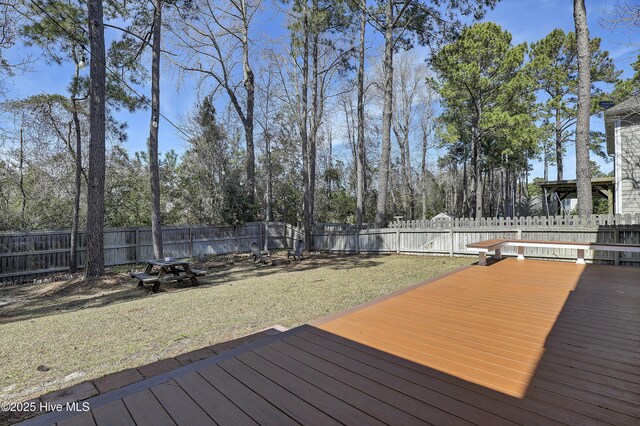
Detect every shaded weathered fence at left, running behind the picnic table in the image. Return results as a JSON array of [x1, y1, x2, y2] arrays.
[[0, 222, 300, 282]]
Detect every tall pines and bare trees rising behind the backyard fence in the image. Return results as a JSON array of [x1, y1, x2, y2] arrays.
[[0, 0, 640, 275]]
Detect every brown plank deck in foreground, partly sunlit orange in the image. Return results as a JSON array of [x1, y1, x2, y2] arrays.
[[20, 259, 640, 426]]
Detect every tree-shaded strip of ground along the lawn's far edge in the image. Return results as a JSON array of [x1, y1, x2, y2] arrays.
[[0, 253, 385, 326]]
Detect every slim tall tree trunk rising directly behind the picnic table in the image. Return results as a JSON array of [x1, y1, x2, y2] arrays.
[[149, 0, 164, 259]]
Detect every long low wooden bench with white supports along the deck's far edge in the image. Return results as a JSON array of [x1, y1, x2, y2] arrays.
[[467, 239, 640, 266]]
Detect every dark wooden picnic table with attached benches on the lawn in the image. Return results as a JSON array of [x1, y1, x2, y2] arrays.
[[131, 258, 205, 293]]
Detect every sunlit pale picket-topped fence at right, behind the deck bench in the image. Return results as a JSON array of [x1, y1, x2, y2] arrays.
[[312, 214, 640, 266]]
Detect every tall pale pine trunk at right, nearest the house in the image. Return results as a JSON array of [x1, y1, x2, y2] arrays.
[[573, 0, 593, 217]]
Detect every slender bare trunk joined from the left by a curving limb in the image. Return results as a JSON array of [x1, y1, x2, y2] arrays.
[[241, 0, 256, 204]]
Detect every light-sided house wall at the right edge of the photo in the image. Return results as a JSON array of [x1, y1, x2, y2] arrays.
[[616, 114, 640, 214]]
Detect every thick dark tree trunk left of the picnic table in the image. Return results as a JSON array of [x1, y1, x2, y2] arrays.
[[85, 0, 106, 277]]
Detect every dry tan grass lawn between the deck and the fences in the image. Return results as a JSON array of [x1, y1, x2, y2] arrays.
[[0, 255, 472, 402]]
